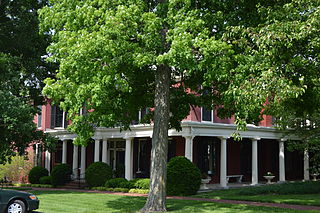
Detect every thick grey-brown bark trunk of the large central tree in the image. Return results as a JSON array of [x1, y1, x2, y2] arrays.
[[141, 65, 170, 213]]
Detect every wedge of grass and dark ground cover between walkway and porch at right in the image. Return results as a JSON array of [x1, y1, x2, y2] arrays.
[[195, 182, 320, 206]]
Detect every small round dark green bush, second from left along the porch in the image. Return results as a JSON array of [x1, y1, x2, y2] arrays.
[[51, 164, 72, 186]]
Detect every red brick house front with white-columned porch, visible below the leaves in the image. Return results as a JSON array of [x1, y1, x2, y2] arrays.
[[35, 104, 309, 188]]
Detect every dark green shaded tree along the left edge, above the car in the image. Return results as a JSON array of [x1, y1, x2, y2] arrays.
[[0, 0, 54, 163]]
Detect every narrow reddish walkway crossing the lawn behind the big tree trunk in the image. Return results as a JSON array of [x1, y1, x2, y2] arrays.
[[27, 187, 320, 211]]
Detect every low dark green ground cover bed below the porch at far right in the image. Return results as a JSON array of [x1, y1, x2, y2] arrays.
[[238, 181, 320, 195]]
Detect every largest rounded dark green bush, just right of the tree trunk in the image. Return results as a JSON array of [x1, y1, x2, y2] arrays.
[[167, 156, 201, 195]]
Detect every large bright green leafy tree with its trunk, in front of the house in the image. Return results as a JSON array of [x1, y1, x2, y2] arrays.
[[39, 0, 319, 212]]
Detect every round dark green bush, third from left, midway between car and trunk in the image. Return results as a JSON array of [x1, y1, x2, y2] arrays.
[[86, 162, 112, 187]]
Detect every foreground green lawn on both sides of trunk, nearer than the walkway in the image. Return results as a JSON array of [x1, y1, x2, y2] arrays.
[[28, 191, 312, 213]]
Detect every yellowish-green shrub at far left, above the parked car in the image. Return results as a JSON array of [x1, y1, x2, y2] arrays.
[[0, 153, 32, 182]]
